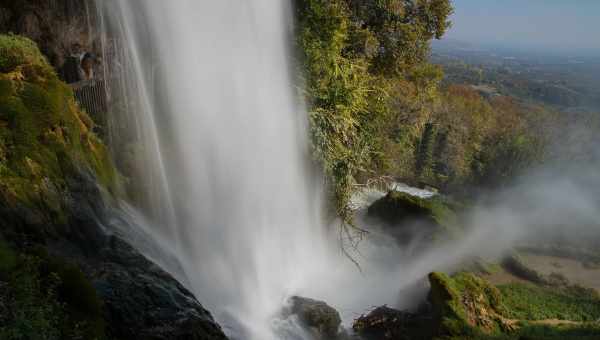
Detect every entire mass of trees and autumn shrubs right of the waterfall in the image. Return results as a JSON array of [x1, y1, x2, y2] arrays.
[[295, 0, 556, 234]]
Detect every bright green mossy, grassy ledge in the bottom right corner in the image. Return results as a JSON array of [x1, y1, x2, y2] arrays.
[[429, 272, 600, 340]]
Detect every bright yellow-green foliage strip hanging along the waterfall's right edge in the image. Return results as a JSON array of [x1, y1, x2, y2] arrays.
[[297, 0, 385, 226]]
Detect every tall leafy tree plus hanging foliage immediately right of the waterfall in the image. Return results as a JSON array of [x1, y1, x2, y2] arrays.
[[295, 0, 451, 230]]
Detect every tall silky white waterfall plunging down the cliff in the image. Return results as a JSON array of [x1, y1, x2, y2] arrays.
[[99, 0, 336, 340]]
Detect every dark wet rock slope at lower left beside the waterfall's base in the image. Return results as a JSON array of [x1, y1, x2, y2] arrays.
[[51, 236, 227, 340]]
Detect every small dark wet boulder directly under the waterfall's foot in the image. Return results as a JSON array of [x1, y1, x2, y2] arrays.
[[289, 296, 344, 340]]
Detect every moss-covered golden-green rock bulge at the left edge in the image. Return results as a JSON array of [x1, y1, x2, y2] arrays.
[[0, 35, 116, 236]]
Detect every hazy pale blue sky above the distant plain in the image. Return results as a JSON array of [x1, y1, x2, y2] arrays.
[[446, 0, 600, 49]]
